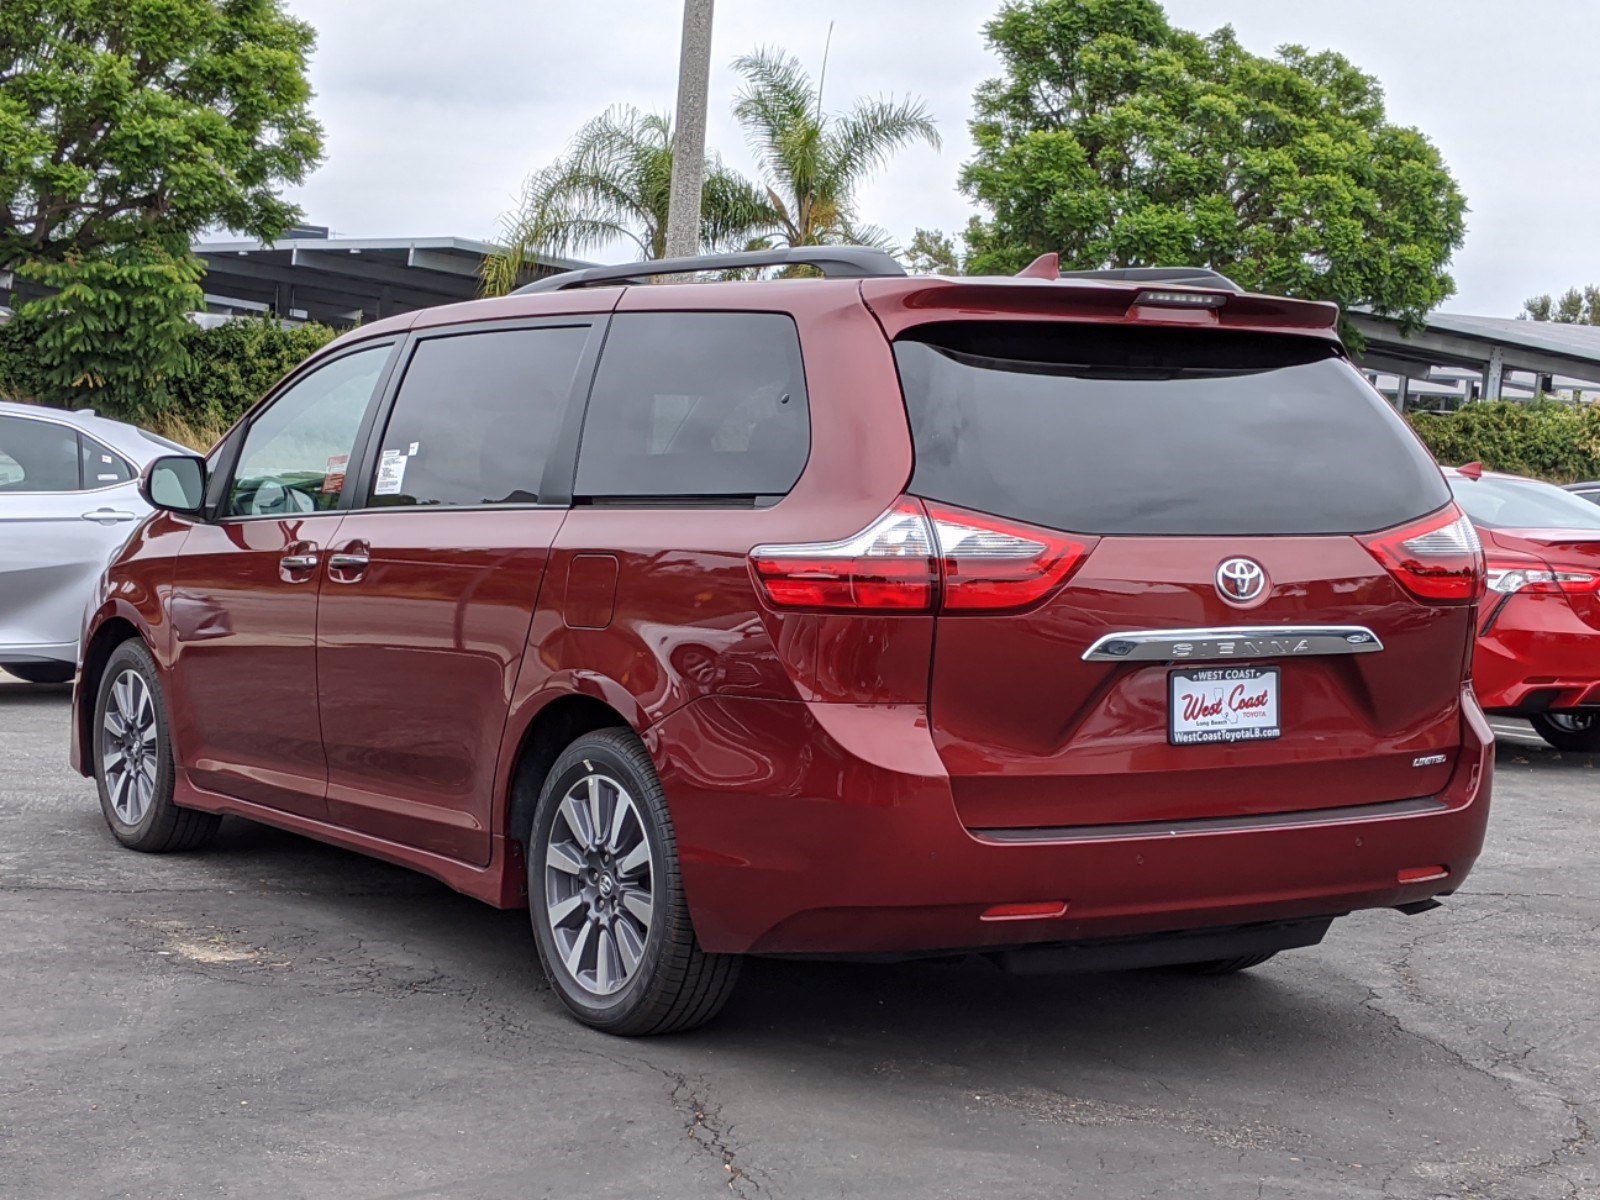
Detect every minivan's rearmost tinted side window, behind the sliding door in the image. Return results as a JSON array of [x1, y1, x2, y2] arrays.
[[574, 312, 811, 499]]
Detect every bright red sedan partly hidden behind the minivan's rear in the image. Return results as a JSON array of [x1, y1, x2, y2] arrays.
[[1445, 462, 1600, 750]]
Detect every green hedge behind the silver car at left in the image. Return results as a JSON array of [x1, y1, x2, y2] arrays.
[[0, 318, 336, 445]]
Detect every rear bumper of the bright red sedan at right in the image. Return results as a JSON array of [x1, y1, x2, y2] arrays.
[[1472, 595, 1600, 715]]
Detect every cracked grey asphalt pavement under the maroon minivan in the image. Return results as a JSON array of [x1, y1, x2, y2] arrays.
[[0, 677, 1600, 1200]]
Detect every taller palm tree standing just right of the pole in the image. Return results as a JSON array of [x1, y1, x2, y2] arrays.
[[733, 50, 939, 246]]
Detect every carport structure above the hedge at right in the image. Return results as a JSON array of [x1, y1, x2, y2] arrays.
[[1346, 312, 1600, 411]]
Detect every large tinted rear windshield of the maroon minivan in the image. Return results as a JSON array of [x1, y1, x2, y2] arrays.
[[894, 322, 1450, 534]]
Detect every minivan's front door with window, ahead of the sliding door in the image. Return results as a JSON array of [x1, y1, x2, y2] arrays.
[[170, 342, 394, 818]]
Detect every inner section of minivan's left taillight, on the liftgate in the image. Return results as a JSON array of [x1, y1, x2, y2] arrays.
[[928, 504, 1093, 613]]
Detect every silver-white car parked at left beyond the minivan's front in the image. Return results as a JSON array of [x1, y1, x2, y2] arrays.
[[0, 400, 186, 683]]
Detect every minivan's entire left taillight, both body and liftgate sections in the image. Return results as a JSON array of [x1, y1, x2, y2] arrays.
[[750, 498, 1094, 613]]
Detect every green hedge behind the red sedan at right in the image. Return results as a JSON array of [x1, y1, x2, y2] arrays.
[[1410, 400, 1600, 483]]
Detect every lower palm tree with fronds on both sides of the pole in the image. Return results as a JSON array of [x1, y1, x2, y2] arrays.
[[482, 106, 778, 296]]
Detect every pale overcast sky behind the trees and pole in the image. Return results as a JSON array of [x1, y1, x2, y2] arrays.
[[278, 0, 1600, 315]]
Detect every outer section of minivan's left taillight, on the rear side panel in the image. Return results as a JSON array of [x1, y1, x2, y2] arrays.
[[750, 499, 939, 613]]
